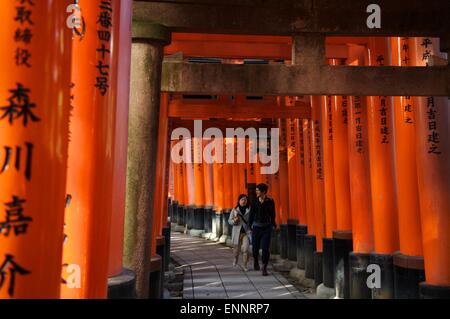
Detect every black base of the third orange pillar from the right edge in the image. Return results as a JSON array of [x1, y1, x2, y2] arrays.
[[370, 253, 395, 299]]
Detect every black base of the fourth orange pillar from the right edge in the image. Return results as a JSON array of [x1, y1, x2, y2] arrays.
[[349, 252, 372, 299]]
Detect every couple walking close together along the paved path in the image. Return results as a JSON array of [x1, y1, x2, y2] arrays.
[[228, 184, 277, 276]]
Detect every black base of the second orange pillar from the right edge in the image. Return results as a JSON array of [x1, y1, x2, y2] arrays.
[[394, 253, 425, 299]]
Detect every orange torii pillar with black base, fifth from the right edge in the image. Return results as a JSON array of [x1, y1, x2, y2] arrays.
[[332, 60, 353, 299]]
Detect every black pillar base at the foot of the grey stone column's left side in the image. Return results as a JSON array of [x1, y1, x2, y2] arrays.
[[108, 268, 136, 299]]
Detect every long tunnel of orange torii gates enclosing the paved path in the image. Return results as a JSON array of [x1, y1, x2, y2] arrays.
[[0, 0, 450, 299]]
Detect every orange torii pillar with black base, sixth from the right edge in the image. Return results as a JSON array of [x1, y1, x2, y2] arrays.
[[321, 94, 336, 289]]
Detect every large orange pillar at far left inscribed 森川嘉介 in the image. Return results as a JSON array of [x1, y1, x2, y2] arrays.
[[0, 1, 71, 299]]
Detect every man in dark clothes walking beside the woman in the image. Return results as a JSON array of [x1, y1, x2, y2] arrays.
[[249, 184, 277, 276]]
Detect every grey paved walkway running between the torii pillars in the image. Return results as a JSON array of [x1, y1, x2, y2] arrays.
[[171, 232, 306, 299]]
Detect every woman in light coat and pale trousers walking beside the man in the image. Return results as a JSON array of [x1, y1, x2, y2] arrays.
[[228, 194, 250, 271]]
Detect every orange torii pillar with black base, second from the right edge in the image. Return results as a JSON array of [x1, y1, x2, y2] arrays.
[[391, 37, 425, 299]]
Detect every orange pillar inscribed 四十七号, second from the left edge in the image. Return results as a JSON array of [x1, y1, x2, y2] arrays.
[[61, 1, 120, 298]]
